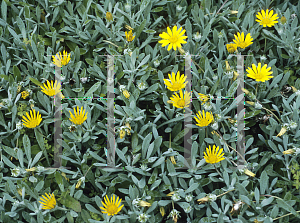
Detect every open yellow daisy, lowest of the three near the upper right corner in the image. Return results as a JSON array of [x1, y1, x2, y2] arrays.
[[246, 63, 274, 82]]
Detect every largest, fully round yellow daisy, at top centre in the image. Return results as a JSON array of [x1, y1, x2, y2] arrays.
[[158, 26, 187, 51]]
